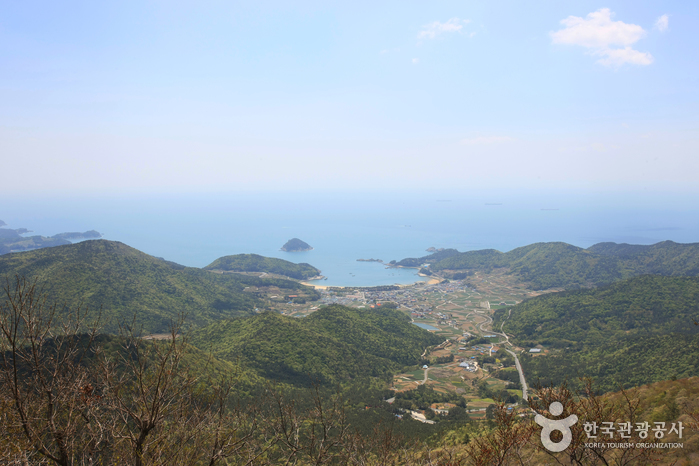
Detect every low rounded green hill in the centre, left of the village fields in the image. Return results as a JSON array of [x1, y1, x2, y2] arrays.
[[192, 305, 443, 385]]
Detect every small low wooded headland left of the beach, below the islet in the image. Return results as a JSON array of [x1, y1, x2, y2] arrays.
[[204, 254, 320, 280]]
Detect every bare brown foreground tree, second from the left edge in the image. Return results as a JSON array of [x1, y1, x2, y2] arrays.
[[97, 317, 274, 466]]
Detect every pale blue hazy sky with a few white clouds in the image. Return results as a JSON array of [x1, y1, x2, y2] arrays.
[[0, 0, 699, 197]]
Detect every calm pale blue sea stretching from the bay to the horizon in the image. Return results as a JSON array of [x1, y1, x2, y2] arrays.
[[0, 187, 699, 286]]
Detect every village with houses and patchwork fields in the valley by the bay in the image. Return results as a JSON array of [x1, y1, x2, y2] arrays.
[[270, 271, 554, 422]]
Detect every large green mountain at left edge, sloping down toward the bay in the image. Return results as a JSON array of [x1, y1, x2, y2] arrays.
[[0, 240, 312, 332]]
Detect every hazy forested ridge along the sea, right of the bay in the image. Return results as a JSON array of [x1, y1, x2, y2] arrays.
[[395, 241, 699, 289]]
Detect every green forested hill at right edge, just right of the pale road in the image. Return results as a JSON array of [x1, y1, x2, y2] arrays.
[[494, 276, 699, 391]]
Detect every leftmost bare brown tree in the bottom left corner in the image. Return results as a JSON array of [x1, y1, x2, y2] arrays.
[[0, 277, 109, 465]]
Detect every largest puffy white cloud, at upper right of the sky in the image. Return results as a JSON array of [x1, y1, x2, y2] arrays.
[[551, 8, 653, 66]]
